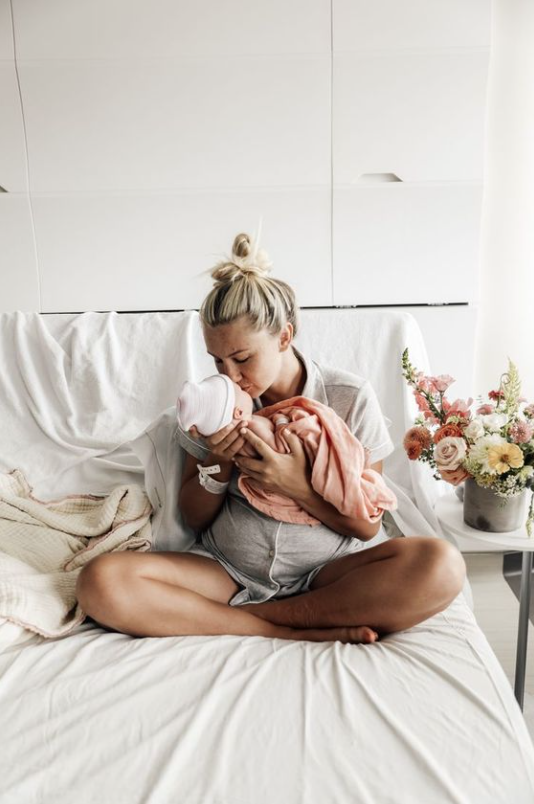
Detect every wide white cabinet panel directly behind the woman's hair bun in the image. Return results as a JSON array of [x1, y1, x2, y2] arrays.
[[33, 188, 332, 312]]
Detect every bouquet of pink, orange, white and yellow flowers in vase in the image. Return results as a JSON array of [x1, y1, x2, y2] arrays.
[[402, 349, 534, 536]]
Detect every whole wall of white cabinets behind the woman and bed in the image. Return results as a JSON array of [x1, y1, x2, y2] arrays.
[[0, 0, 491, 312]]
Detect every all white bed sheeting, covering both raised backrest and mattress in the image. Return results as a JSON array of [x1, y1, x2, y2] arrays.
[[0, 310, 534, 804]]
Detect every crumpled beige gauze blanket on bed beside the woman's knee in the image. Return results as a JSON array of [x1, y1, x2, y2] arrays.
[[0, 469, 152, 637]]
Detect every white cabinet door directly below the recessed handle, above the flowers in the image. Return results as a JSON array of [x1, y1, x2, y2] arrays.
[[333, 183, 482, 305]]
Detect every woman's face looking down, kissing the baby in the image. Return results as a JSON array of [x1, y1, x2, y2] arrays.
[[203, 318, 292, 398]]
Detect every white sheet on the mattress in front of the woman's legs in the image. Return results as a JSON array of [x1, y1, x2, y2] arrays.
[[0, 597, 534, 804]]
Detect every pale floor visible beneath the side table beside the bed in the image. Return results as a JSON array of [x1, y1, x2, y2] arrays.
[[463, 553, 534, 741]]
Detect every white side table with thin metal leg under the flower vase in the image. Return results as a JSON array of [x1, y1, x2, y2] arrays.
[[435, 493, 534, 709]]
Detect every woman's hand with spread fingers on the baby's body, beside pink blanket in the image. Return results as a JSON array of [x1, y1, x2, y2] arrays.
[[234, 425, 313, 502]]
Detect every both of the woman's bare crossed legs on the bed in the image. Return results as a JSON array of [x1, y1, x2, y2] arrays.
[[76, 536, 465, 642]]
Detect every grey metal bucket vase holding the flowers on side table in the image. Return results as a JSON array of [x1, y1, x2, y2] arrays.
[[464, 477, 529, 533]]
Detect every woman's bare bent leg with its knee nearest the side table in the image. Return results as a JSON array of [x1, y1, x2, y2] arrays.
[[241, 536, 465, 635]]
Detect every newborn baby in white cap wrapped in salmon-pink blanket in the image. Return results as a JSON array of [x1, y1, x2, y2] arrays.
[[176, 374, 397, 525]]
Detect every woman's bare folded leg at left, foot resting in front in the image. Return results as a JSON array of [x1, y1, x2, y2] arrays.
[[76, 552, 377, 642]]
